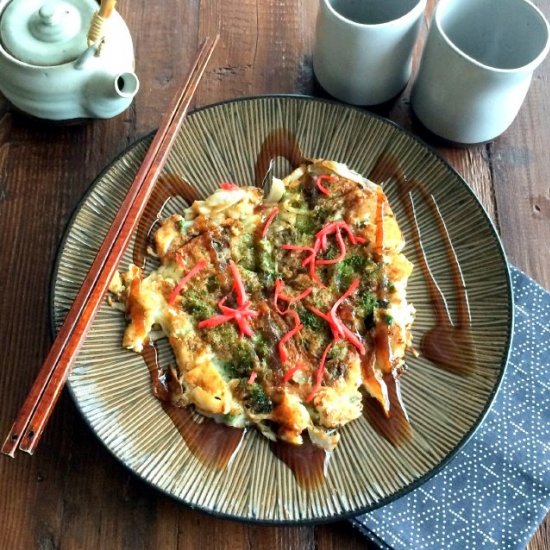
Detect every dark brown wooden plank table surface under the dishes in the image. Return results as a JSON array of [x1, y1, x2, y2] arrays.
[[0, 0, 550, 550]]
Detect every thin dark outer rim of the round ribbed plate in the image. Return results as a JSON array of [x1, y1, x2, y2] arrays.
[[48, 93, 515, 527]]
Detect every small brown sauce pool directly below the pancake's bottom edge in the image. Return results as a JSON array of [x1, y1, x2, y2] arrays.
[[271, 437, 330, 491]]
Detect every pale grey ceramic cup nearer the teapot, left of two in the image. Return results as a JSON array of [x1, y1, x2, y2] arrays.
[[313, 0, 426, 105]]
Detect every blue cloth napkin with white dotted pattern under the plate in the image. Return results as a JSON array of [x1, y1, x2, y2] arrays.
[[352, 268, 550, 550]]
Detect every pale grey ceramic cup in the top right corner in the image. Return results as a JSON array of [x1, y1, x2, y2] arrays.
[[411, 0, 550, 144]]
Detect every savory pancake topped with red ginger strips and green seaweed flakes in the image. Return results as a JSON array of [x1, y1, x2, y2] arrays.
[[111, 160, 414, 449]]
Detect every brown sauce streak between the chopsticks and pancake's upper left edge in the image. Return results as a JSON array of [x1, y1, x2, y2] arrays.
[[132, 174, 200, 267]]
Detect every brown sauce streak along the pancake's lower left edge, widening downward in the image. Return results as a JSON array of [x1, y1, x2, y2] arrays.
[[142, 344, 245, 470]]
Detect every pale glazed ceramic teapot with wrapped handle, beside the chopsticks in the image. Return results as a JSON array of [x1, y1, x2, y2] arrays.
[[0, 0, 139, 120]]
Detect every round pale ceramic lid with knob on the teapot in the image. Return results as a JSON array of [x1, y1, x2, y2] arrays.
[[0, 0, 98, 66]]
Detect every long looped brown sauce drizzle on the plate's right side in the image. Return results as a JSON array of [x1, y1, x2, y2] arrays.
[[369, 154, 475, 375]]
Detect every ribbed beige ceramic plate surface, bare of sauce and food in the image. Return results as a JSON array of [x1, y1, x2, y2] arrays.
[[52, 96, 512, 523]]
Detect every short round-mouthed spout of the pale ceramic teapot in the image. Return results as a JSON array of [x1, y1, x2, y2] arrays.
[[86, 71, 139, 118]]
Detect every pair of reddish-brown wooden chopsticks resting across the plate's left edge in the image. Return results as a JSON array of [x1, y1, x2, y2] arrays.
[[1, 35, 219, 457]]
